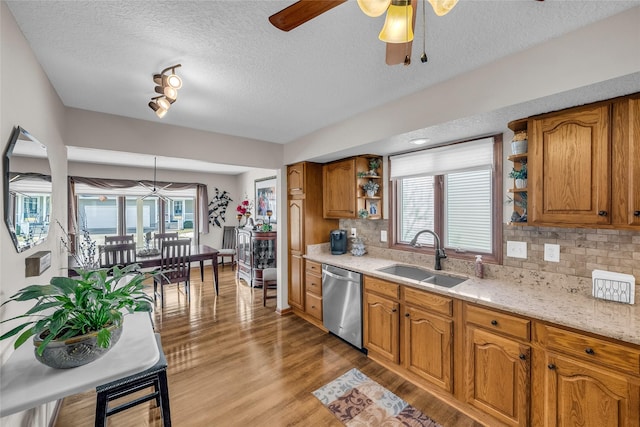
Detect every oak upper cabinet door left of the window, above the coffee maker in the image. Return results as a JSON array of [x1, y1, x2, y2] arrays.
[[322, 158, 356, 218]]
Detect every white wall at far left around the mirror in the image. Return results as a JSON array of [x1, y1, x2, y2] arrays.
[[0, 2, 67, 427]]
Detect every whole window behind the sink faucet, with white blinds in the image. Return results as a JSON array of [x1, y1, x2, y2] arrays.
[[390, 136, 502, 262]]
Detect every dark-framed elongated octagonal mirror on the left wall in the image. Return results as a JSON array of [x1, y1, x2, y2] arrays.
[[3, 126, 51, 252]]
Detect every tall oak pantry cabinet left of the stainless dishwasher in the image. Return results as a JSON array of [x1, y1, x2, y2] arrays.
[[287, 162, 338, 325]]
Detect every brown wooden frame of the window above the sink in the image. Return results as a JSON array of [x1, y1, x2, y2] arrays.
[[387, 134, 503, 264]]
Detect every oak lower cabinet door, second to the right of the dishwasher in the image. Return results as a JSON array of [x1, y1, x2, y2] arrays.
[[402, 306, 453, 392]]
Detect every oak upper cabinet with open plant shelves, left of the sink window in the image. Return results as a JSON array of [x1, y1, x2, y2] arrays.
[[322, 155, 384, 219]]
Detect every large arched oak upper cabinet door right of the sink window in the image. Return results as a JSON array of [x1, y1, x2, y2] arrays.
[[529, 105, 611, 225]]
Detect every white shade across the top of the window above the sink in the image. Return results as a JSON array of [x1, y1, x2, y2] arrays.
[[389, 138, 493, 179]]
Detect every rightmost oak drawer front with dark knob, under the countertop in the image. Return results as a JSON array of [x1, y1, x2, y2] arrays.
[[536, 324, 640, 374]]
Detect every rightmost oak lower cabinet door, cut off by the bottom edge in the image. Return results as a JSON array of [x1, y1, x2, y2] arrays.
[[545, 353, 640, 427]]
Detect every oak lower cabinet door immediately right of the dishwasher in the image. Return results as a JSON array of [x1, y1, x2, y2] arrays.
[[363, 292, 400, 363]]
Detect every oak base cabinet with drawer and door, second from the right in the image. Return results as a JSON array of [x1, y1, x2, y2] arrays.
[[464, 304, 531, 426]]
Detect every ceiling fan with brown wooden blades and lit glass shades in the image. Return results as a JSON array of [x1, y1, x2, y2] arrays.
[[269, 0, 544, 65]]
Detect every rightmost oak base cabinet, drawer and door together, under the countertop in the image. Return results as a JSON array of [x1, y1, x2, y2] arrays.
[[534, 323, 640, 427]]
